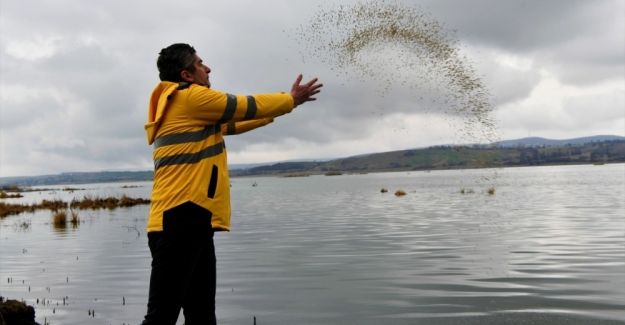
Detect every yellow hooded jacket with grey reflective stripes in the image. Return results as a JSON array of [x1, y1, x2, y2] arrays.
[[145, 81, 294, 232]]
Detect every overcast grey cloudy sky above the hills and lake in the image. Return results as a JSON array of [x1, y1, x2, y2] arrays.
[[0, 0, 625, 177]]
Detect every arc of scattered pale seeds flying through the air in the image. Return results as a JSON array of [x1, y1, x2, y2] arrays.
[[294, 0, 499, 177]]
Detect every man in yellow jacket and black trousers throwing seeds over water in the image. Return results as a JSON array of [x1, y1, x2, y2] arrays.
[[143, 44, 323, 325]]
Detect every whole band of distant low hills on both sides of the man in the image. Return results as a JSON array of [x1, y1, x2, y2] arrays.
[[0, 135, 625, 186]]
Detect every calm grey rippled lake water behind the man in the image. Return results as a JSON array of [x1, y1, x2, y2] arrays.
[[0, 164, 625, 325]]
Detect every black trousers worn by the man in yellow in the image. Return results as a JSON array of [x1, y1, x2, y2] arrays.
[[142, 227, 217, 325]]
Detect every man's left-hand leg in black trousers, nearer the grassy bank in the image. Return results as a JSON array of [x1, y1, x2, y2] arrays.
[[142, 231, 205, 325]]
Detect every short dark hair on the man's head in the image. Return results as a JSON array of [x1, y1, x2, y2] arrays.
[[156, 43, 195, 82]]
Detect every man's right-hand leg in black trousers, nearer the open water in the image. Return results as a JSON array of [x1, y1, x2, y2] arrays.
[[182, 234, 217, 325]]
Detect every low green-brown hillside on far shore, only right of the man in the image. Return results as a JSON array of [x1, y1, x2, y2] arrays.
[[231, 140, 625, 176]]
